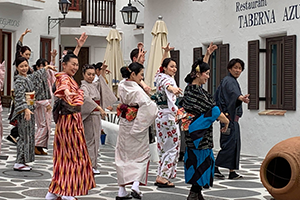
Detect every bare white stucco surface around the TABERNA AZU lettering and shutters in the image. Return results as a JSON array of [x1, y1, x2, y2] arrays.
[[144, 0, 300, 156]]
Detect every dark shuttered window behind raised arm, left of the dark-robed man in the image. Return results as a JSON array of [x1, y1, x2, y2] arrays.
[[193, 44, 229, 95]]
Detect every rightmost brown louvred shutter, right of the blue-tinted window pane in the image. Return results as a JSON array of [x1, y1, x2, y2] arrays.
[[282, 35, 296, 110]]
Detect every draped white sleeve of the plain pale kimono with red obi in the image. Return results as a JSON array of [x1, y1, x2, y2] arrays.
[[130, 88, 158, 138]]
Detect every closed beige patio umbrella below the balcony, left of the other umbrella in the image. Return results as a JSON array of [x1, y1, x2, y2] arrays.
[[104, 27, 124, 88]]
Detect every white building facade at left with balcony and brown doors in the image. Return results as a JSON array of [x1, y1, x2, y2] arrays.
[[0, 0, 144, 99]]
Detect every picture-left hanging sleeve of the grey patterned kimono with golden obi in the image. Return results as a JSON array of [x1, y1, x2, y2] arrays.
[[14, 79, 28, 114]]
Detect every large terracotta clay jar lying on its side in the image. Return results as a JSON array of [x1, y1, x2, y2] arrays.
[[260, 137, 300, 200]]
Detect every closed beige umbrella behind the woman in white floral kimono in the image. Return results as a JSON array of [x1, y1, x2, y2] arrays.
[[145, 16, 170, 89]]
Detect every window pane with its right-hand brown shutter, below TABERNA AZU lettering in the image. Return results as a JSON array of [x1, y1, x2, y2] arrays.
[[266, 36, 296, 110]]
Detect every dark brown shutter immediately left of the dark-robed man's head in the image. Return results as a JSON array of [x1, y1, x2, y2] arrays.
[[216, 44, 229, 86]]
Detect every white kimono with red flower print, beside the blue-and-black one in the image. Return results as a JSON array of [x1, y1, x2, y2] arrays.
[[155, 73, 180, 179]]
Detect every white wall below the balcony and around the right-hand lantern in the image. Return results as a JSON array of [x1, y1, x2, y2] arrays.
[[61, 0, 144, 67]]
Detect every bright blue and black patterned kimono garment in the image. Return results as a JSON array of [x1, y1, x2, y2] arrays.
[[181, 84, 221, 187]]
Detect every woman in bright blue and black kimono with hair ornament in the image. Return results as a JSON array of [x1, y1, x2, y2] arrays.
[[178, 58, 229, 200]]
